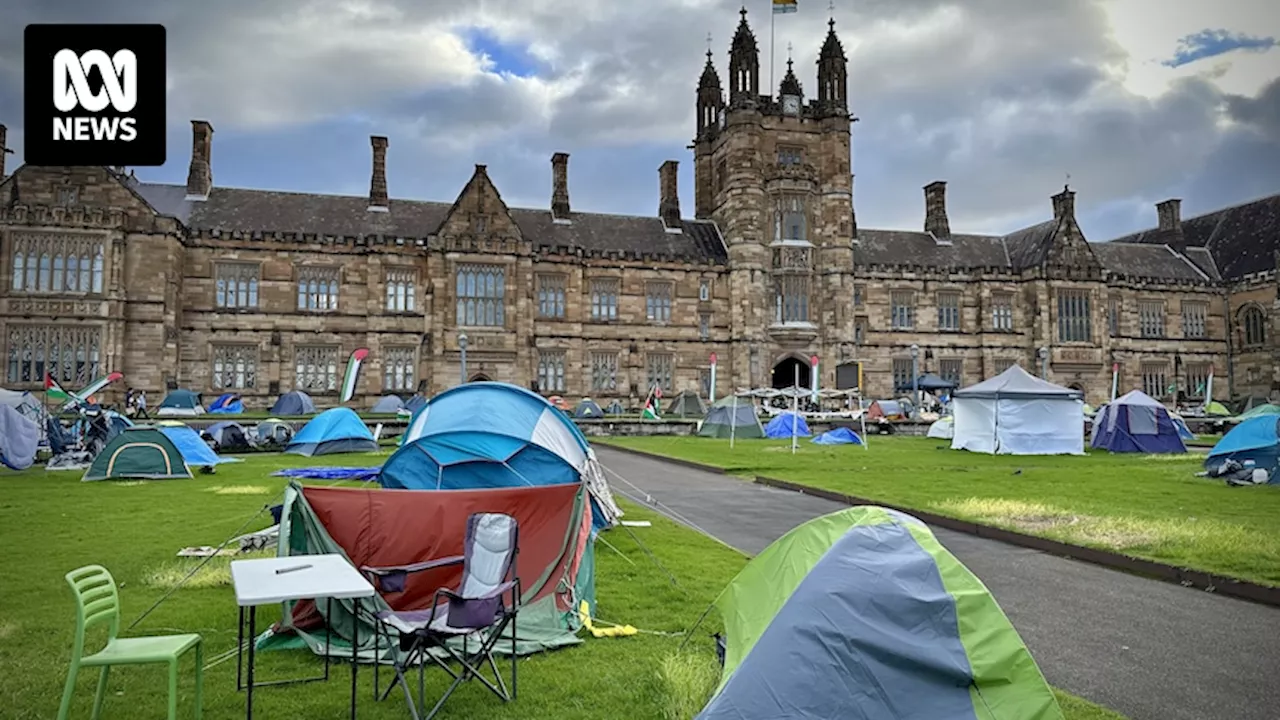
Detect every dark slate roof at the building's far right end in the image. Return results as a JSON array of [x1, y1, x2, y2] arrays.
[[1114, 195, 1280, 279]]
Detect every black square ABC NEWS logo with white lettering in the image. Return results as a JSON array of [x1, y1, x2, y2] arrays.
[[23, 24, 166, 165]]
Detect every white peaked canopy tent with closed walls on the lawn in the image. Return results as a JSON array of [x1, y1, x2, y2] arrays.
[[951, 365, 1084, 455]]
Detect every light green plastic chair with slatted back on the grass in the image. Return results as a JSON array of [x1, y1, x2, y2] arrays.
[[58, 565, 204, 720]]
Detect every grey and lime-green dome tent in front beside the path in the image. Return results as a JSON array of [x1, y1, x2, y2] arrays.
[[698, 506, 1062, 720]]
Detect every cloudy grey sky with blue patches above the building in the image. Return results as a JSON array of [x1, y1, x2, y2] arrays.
[[0, 0, 1280, 240]]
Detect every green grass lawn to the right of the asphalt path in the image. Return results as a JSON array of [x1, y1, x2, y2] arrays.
[[604, 436, 1280, 585]]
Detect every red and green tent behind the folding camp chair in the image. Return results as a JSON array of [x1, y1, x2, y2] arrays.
[[260, 482, 595, 660]]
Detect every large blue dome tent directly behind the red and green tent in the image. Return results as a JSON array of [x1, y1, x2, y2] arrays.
[[380, 382, 622, 529]]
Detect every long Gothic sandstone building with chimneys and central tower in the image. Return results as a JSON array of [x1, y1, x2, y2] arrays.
[[0, 10, 1280, 406]]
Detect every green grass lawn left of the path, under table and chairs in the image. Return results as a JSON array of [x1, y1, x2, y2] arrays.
[[0, 451, 1119, 720]]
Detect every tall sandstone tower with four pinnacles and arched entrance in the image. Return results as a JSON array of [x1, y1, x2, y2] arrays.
[[692, 8, 854, 387]]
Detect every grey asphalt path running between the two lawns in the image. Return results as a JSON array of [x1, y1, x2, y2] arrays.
[[595, 445, 1280, 720]]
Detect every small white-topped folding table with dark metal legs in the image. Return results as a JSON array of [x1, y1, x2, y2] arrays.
[[232, 553, 375, 720]]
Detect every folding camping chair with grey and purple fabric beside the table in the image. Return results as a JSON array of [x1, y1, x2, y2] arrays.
[[361, 512, 520, 720]]
